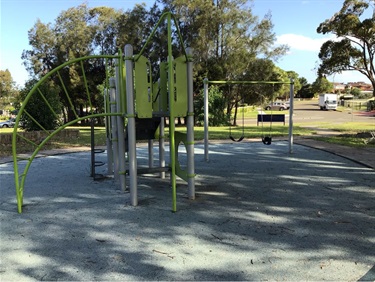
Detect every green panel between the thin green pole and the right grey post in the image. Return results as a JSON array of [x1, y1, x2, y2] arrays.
[[172, 56, 188, 117]]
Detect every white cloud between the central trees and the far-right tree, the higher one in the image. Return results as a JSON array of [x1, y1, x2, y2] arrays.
[[276, 33, 335, 52]]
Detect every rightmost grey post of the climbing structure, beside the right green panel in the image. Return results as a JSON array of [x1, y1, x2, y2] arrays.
[[186, 48, 195, 199]]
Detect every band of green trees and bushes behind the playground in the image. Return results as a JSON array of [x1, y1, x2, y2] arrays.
[[0, 0, 375, 133]]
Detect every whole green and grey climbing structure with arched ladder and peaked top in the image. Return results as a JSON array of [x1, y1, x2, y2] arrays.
[[12, 13, 195, 213]]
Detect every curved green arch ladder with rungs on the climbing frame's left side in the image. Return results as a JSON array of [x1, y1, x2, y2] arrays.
[[12, 54, 123, 213]]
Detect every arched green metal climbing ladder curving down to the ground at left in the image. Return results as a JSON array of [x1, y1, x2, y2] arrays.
[[12, 53, 125, 213]]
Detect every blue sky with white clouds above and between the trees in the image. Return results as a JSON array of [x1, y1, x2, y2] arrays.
[[0, 0, 369, 86]]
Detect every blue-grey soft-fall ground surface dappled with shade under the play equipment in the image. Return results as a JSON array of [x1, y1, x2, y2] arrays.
[[0, 139, 375, 281]]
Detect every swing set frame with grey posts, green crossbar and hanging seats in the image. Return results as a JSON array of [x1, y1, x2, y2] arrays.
[[203, 78, 294, 162]]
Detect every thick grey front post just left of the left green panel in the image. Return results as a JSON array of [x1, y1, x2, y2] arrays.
[[124, 44, 138, 206]]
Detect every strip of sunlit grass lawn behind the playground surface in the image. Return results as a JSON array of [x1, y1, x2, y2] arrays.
[[0, 122, 375, 157]]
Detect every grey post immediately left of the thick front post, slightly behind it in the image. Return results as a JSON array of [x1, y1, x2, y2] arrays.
[[116, 64, 126, 191]]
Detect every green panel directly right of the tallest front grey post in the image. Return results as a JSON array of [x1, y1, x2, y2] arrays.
[[134, 56, 152, 118]]
